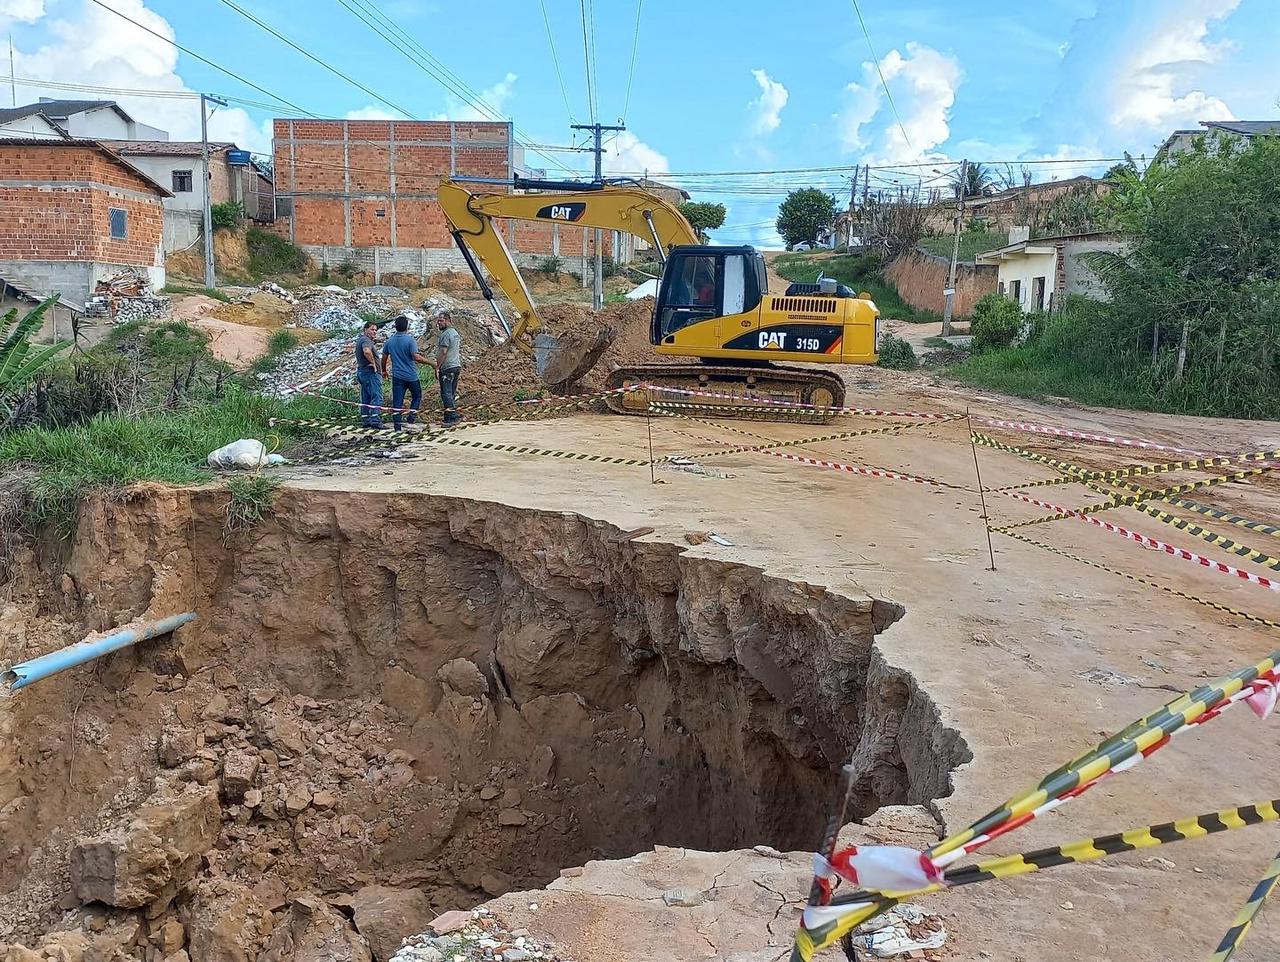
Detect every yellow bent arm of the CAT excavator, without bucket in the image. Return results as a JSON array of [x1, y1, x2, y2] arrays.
[[436, 180, 699, 351]]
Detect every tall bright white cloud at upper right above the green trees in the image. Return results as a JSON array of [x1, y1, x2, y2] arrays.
[[1107, 0, 1240, 130]]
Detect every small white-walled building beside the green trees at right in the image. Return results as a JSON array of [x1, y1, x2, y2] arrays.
[[974, 228, 1125, 313]]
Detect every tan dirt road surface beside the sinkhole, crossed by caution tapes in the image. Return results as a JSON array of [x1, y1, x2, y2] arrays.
[[285, 370, 1280, 962]]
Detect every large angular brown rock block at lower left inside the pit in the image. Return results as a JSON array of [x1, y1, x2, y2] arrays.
[[70, 788, 221, 908]]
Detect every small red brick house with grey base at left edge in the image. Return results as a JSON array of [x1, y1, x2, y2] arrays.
[[0, 139, 170, 310]]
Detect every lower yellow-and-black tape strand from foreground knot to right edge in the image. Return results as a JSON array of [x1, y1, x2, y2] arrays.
[[791, 798, 1280, 962]]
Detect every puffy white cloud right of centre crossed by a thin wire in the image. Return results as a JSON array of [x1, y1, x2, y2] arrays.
[[837, 41, 964, 164]]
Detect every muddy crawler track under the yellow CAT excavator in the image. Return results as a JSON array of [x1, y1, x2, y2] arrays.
[[605, 363, 845, 423]]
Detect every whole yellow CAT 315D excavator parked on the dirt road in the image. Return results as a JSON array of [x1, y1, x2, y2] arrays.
[[436, 178, 879, 413]]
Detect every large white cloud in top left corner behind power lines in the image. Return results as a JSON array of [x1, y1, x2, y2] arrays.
[[10, 0, 271, 152]]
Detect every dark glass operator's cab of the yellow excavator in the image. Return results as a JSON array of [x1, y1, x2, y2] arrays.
[[649, 244, 768, 344]]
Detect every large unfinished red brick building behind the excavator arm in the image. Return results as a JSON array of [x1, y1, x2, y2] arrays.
[[274, 120, 632, 283]]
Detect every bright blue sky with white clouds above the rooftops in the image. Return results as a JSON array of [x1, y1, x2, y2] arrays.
[[0, 0, 1280, 247]]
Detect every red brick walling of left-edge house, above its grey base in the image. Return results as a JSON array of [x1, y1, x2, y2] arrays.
[[0, 142, 164, 267]]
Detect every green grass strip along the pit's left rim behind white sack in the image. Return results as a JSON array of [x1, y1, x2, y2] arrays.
[[0, 386, 348, 536]]
